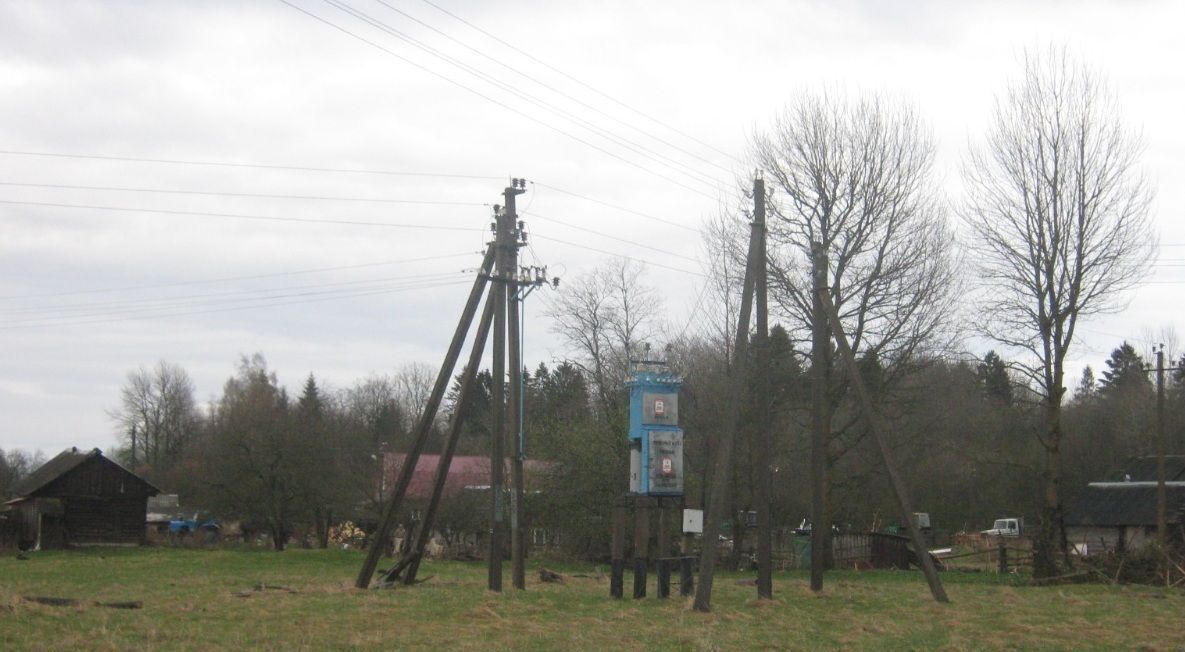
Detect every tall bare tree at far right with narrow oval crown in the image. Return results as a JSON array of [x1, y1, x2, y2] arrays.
[[965, 49, 1154, 576]]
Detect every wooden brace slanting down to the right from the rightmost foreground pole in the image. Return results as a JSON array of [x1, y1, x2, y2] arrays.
[[812, 290, 950, 602]]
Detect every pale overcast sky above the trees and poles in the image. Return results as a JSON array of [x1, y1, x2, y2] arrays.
[[0, 0, 1185, 454]]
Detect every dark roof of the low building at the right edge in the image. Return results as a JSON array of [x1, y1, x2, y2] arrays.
[[1065, 482, 1185, 528]]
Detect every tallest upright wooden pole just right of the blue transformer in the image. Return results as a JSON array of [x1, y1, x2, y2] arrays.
[[741, 177, 774, 600]]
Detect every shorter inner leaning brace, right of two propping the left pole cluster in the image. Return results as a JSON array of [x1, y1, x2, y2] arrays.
[[393, 292, 494, 584]]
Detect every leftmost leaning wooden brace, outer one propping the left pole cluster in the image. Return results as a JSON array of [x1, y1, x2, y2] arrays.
[[354, 245, 495, 589]]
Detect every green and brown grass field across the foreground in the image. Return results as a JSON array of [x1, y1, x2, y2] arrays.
[[0, 548, 1185, 651]]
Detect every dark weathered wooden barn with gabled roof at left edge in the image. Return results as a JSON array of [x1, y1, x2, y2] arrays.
[[6, 448, 160, 549]]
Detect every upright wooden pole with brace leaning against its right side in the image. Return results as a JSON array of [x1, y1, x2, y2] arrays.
[[811, 242, 831, 592]]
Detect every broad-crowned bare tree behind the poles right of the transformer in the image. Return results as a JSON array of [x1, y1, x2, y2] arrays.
[[754, 92, 956, 561]]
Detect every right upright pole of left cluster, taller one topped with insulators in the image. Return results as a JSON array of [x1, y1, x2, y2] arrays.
[[502, 180, 526, 590]]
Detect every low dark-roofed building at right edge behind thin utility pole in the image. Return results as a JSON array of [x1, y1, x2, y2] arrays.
[[1065, 455, 1185, 555]]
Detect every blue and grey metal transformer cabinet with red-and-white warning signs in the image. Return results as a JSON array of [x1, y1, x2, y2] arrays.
[[626, 363, 683, 496]]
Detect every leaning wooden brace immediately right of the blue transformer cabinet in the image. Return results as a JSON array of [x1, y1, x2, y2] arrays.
[[693, 194, 758, 612]]
